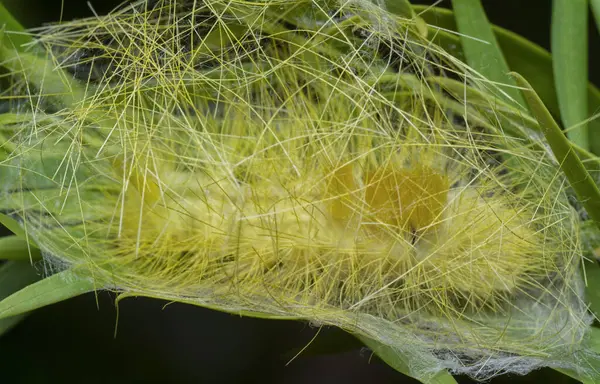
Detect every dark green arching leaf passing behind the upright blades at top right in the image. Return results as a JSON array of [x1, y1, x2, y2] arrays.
[[413, 4, 600, 155]]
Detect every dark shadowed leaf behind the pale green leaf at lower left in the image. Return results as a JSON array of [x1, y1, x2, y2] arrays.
[[0, 261, 39, 335]]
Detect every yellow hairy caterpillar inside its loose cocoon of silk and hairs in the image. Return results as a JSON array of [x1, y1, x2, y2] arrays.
[[0, 0, 590, 377]]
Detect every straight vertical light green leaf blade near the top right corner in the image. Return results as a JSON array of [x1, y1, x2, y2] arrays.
[[552, 0, 589, 149]]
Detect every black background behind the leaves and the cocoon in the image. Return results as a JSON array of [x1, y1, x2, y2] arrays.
[[0, 0, 600, 384]]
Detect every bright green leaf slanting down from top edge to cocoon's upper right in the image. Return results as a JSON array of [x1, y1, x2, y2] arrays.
[[452, 0, 525, 107]]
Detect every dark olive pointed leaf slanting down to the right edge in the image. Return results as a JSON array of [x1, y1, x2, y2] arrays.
[[513, 73, 600, 227]]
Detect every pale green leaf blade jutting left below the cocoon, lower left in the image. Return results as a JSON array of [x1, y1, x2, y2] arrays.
[[0, 270, 102, 319]]
